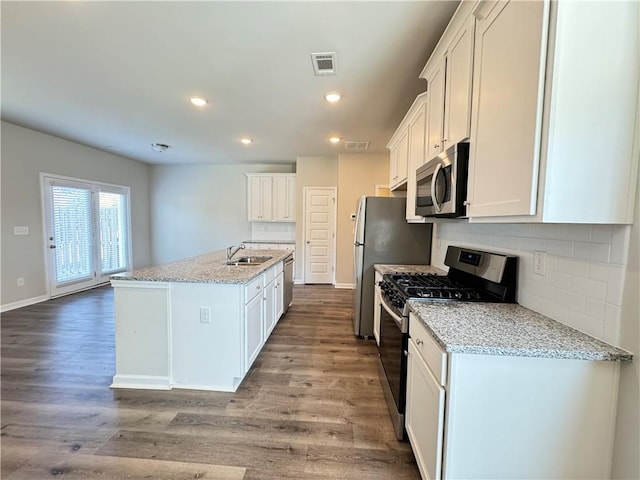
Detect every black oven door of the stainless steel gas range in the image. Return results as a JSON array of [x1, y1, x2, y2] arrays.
[[378, 298, 409, 420]]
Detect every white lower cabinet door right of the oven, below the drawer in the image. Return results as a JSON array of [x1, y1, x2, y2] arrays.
[[406, 339, 445, 480]]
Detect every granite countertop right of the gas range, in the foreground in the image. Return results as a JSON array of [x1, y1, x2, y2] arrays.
[[407, 300, 633, 361]]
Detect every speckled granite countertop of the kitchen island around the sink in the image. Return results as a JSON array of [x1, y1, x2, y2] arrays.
[[110, 250, 291, 284]]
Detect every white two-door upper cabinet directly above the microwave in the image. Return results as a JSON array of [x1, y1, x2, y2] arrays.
[[420, 2, 475, 159]]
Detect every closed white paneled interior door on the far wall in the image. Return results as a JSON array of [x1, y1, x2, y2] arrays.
[[304, 187, 336, 284]]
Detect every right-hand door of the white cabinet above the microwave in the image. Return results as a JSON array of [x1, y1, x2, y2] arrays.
[[444, 17, 475, 148]]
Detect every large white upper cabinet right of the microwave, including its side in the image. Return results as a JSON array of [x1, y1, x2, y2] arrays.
[[467, 1, 640, 223]]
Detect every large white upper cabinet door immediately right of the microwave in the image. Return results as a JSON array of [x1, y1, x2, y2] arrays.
[[467, 1, 548, 217]]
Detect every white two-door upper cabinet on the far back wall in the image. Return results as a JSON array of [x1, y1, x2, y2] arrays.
[[246, 173, 296, 222]]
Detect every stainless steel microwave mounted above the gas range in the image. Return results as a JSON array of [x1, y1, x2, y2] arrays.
[[416, 143, 469, 217]]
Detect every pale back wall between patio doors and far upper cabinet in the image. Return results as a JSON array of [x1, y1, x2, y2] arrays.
[[151, 164, 295, 264]]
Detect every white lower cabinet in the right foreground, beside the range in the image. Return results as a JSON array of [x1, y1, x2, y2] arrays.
[[406, 314, 620, 480]]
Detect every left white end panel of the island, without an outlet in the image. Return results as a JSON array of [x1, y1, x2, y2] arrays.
[[111, 281, 171, 390]]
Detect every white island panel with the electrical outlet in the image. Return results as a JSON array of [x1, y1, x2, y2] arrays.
[[170, 283, 245, 391]]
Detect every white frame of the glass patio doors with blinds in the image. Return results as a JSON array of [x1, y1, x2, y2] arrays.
[[39, 172, 133, 299]]
